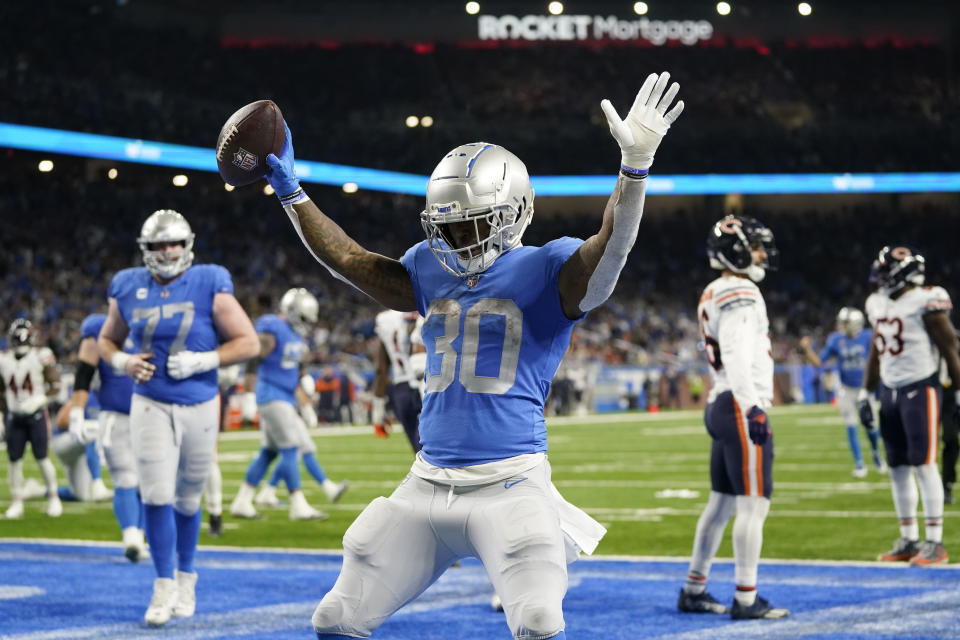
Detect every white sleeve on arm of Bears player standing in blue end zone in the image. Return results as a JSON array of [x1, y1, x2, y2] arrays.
[[717, 304, 760, 413]]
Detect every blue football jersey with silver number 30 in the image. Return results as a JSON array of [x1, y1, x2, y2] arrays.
[[401, 238, 583, 467]]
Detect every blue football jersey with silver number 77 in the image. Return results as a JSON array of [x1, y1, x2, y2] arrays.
[[109, 264, 233, 405]]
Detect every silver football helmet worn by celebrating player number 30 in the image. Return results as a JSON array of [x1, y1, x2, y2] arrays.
[[420, 142, 533, 277]]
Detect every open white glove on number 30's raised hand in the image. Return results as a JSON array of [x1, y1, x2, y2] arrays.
[[600, 71, 683, 176]]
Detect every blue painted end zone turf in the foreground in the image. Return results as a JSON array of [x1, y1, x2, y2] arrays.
[[0, 542, 960, 640]]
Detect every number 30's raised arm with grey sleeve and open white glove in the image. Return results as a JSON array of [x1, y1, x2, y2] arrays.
[[559, 71, 683, 318]]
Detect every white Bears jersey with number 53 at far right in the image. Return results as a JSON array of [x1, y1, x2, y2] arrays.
[[867, 287, 953, 389]]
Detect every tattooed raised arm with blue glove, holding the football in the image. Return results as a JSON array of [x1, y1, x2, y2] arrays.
[[266, 124, 417, 311]]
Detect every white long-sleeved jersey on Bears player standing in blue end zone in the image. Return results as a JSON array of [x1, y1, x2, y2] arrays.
[[697, 276, 773, 412]]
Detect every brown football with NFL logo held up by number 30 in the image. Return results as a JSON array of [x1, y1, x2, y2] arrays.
[[217, 100, 286, 187]]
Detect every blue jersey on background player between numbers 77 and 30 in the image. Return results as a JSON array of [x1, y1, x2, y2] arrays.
[[255, 314, 307, 405]]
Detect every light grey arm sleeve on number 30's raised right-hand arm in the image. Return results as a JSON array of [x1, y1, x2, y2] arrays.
[[579, 178, 647, 313]]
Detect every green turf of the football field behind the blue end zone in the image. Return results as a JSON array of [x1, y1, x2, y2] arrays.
[[0, 405, 960, 560]]
